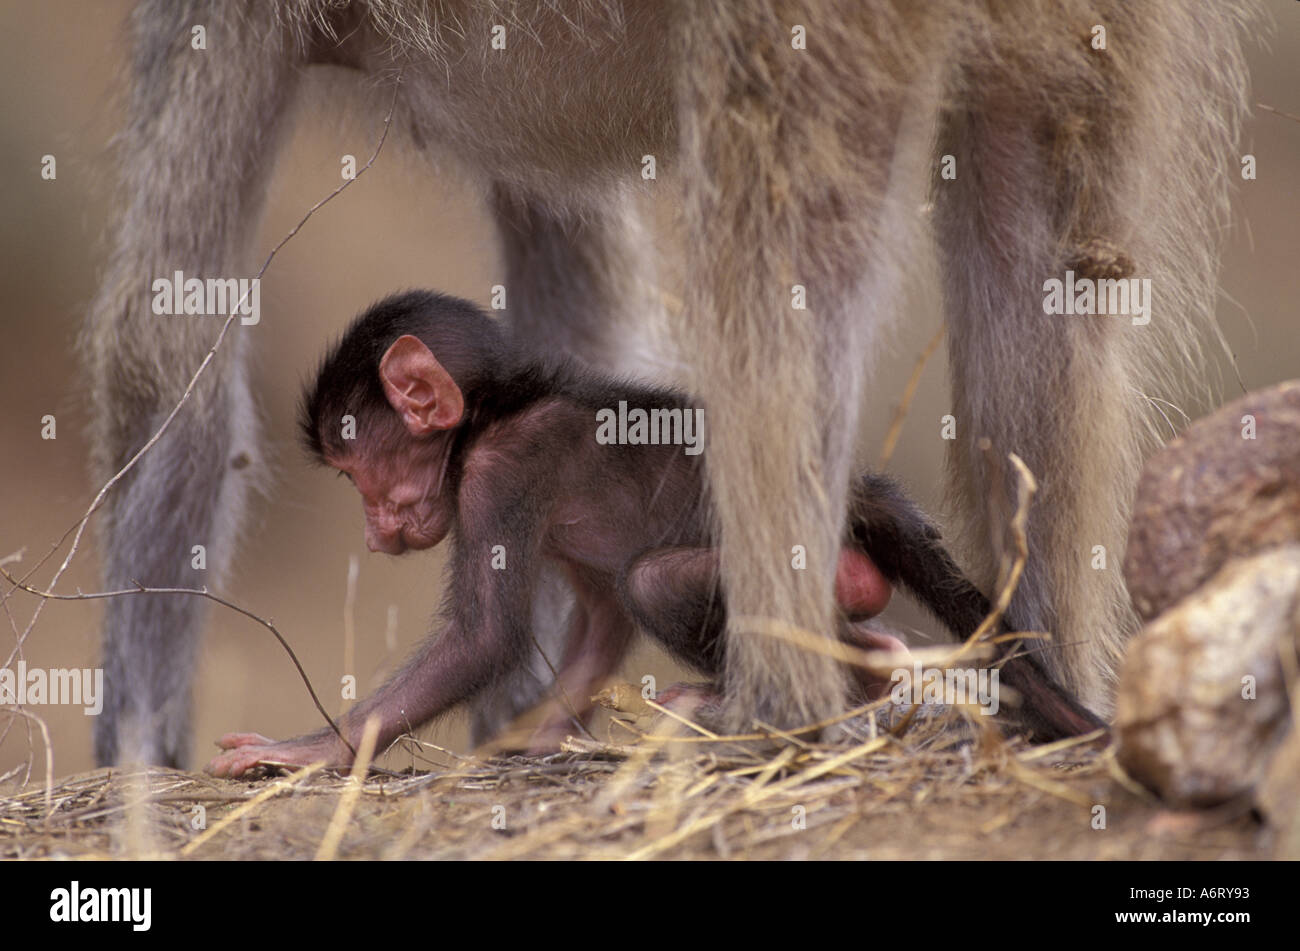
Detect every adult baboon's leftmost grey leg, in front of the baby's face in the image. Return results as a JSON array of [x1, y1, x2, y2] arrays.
[[87, 1, 304, 765]]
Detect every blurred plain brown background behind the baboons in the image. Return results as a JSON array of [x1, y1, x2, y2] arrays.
[[0, 0, 1300, 776]]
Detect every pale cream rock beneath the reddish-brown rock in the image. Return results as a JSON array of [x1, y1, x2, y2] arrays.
[[1115, 544, 1300, 805]]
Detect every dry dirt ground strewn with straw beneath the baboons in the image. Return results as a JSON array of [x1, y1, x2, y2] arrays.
[[0, 708, 1275, 860]]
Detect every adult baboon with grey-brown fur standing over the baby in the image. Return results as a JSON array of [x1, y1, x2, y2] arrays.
[[90, 0, 1245, 764]]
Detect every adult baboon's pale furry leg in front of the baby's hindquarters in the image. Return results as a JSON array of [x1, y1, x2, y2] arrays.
[[679, 3, 928, 729]]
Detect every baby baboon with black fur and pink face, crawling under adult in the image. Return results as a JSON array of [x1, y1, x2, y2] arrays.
[[208, 291, 1101, 776]]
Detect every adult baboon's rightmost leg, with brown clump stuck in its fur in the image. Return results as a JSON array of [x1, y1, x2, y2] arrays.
[[933, 3, 1245, 713]]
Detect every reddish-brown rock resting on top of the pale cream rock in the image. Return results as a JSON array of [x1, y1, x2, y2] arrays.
[[1125, 381, 1300, 621]]
